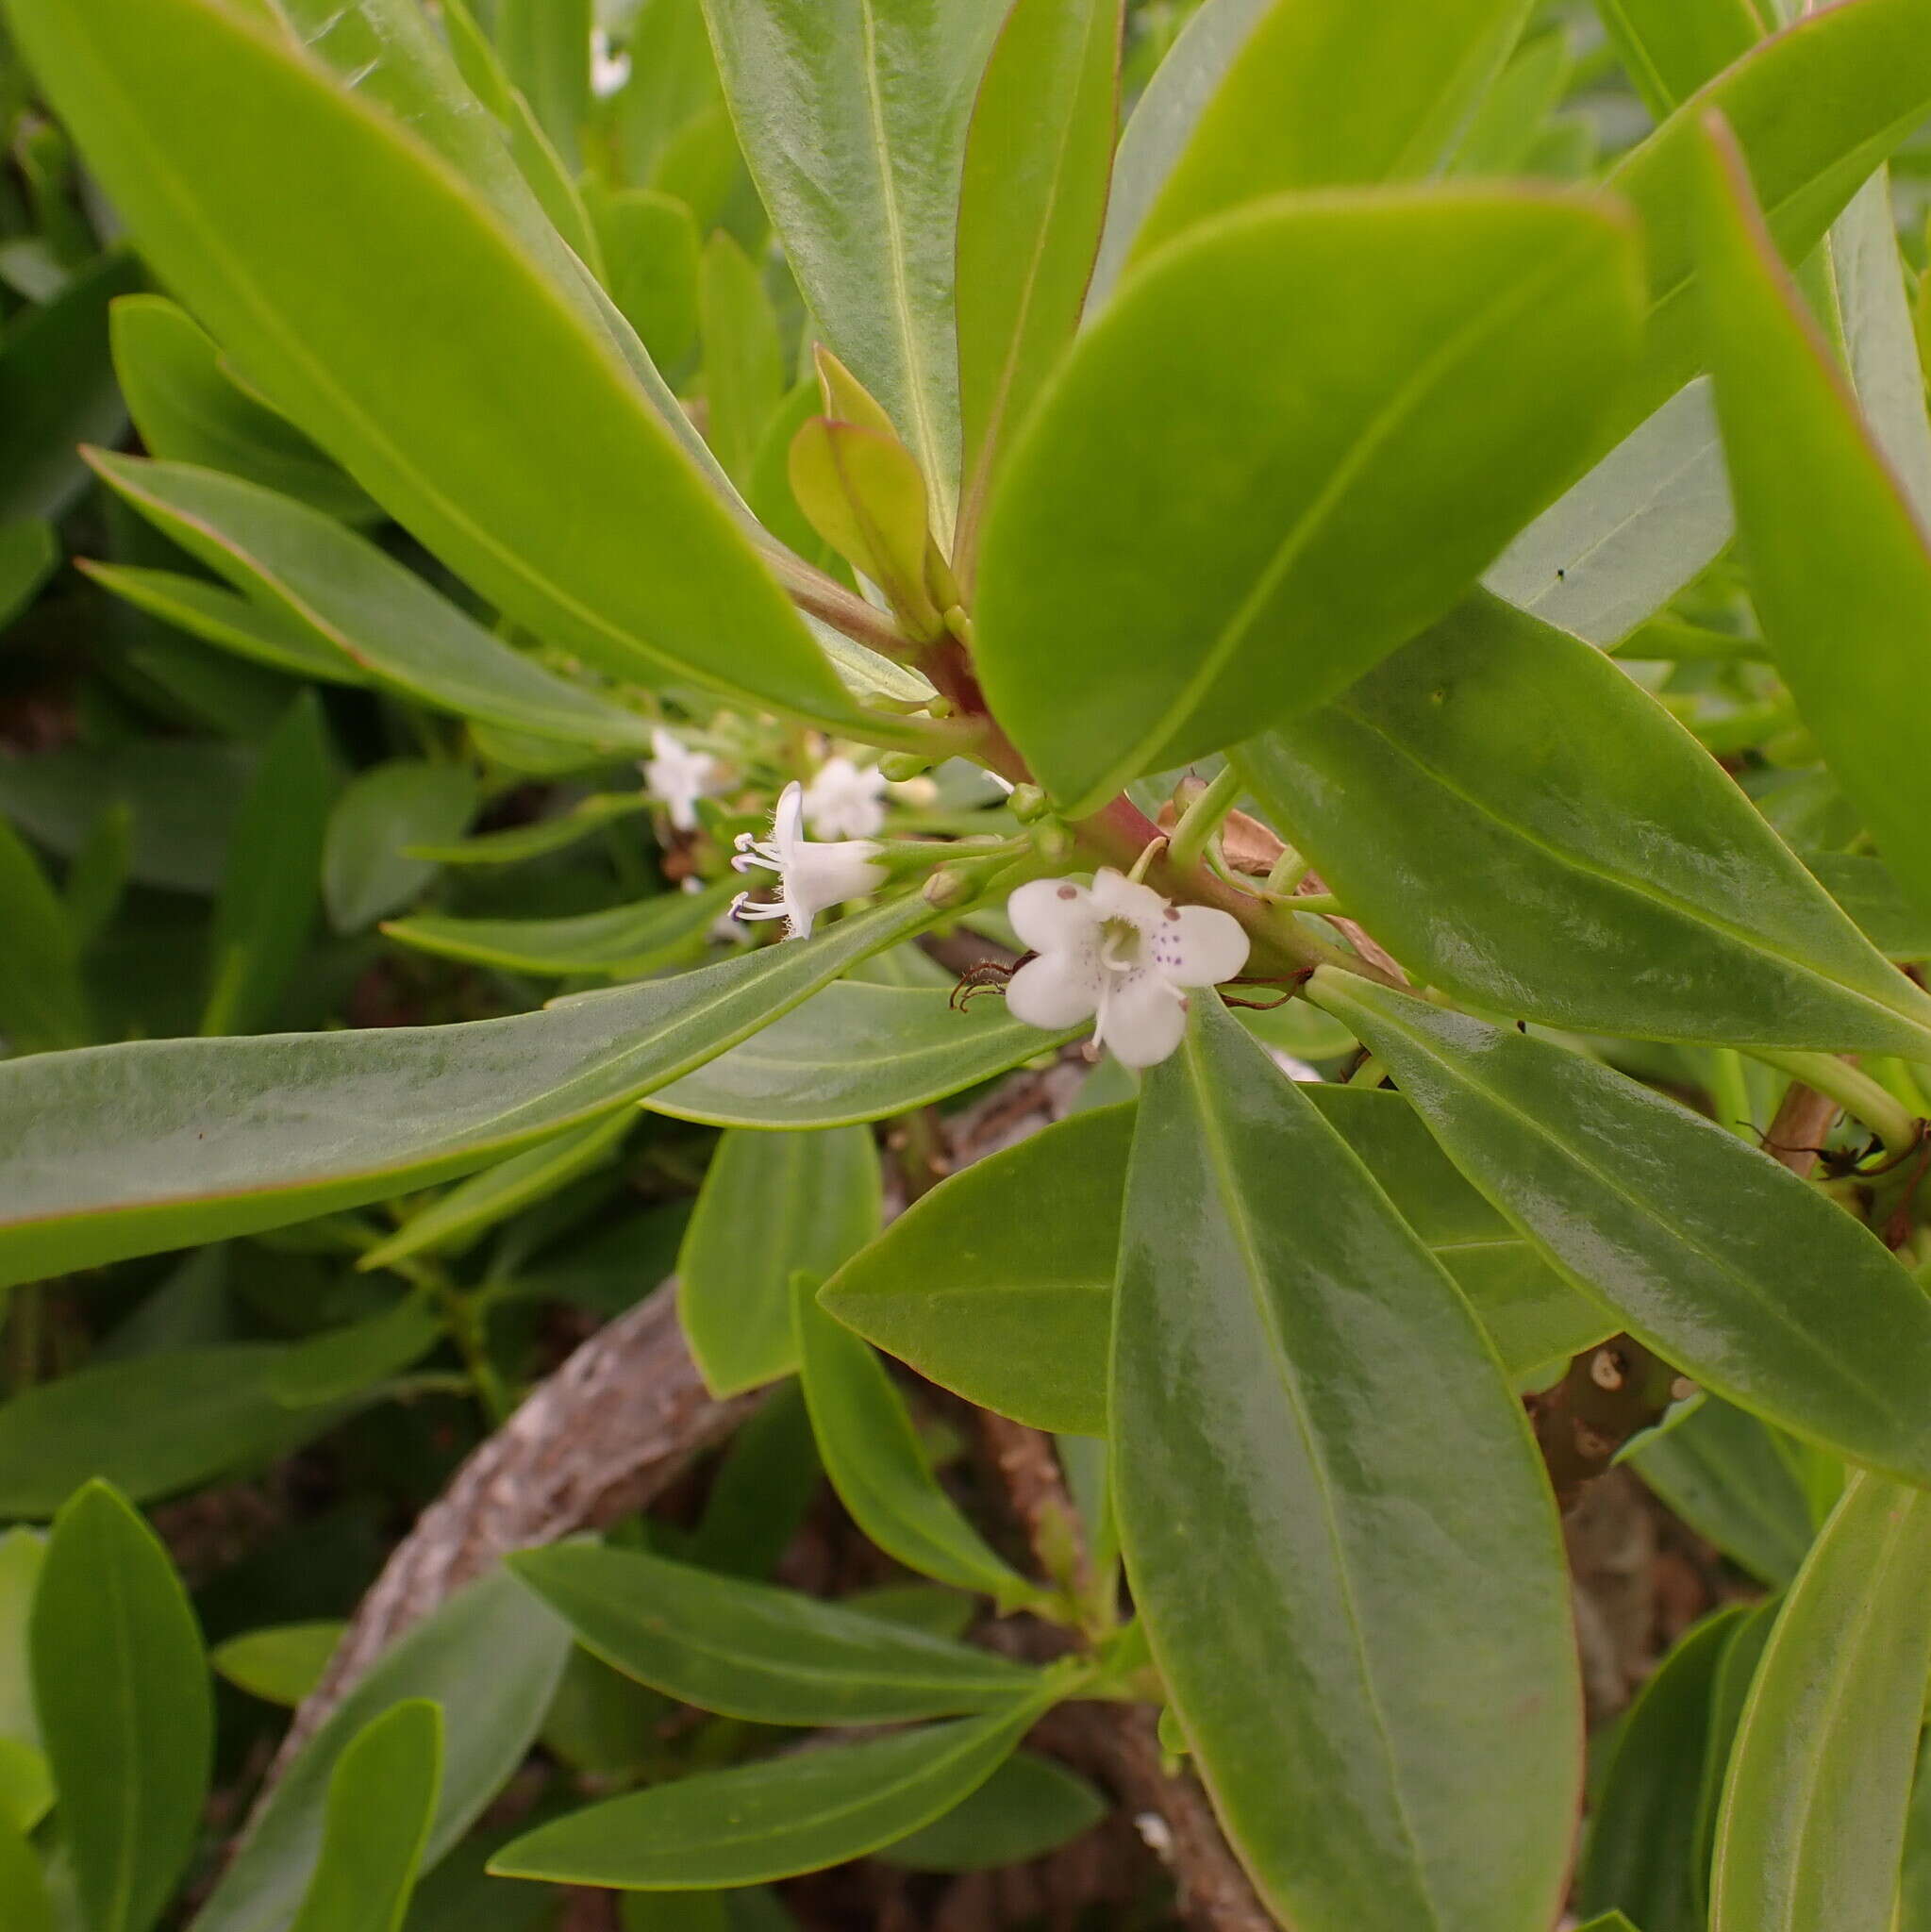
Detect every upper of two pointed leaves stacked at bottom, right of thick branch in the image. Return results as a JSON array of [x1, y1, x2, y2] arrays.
[[511, 1543, 1039, 1725]]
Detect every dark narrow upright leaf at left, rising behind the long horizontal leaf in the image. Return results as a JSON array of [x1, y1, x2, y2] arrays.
[[201, 691, 338, 1036]]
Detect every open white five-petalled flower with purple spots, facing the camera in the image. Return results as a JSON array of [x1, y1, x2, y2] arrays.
[[1006, 870, 1247, 1066]]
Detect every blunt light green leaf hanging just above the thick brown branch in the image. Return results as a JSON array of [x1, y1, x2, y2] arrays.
[[677, 1126, 885, 1397]]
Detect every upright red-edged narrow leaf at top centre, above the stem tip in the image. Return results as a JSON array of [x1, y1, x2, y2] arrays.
[[954, 0, 1124, 586]]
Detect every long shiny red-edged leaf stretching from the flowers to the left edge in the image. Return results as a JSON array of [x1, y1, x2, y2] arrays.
[[0, 898, 933, 1281]]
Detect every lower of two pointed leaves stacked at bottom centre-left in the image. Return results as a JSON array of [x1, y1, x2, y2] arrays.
[[491, 1694, 1053, 1891]]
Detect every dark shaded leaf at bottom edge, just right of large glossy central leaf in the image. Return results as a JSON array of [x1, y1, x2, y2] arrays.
[[1575, 1604, 1750, 1932]]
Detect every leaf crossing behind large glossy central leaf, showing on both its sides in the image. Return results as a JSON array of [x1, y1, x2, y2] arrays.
[[819, 1086, 1610, 1436]]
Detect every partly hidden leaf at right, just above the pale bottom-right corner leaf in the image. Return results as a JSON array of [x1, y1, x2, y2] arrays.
[[1628, 1397, 1811, 1588]]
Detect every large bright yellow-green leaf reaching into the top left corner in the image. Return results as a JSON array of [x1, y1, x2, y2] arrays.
[[9, 0, 848, 719]]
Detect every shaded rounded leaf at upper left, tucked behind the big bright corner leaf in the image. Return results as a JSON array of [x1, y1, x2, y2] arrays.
[[112, 295, 378, 522]]
